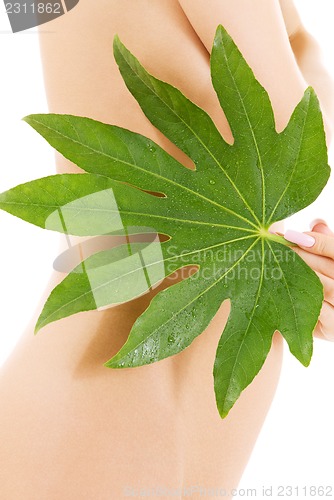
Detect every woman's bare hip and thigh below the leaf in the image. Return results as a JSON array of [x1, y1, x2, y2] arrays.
[[0, 301, 282, 500]]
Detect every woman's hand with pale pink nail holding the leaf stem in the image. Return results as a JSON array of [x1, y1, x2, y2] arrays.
[[284, 219, 334, 342]]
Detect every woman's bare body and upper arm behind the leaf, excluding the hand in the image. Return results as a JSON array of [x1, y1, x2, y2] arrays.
[[0, 0, 331, 500]]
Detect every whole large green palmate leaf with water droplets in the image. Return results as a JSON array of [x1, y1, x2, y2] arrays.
[[0, 26, 330, 418]]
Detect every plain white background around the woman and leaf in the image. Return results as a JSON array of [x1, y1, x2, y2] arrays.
[[0, 0, 334, 498]]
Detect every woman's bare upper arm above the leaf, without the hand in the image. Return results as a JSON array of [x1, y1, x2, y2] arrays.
[[179, 0, 331, 142]]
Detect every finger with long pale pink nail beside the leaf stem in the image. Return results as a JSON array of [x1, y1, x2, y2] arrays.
[[284, 229, 334, 259]]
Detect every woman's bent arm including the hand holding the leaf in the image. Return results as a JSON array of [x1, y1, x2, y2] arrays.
[[179, 0, 334, 339]]
